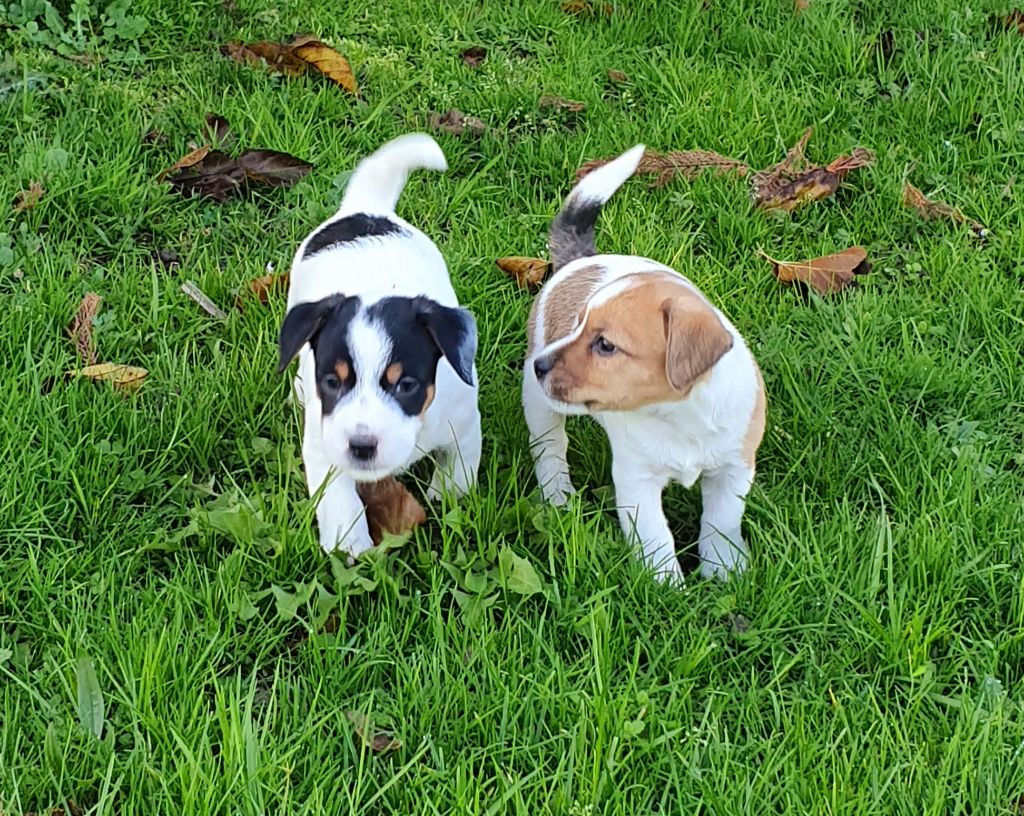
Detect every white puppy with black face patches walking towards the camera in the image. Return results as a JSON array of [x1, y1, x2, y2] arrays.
[[279, 134, 480, 558]]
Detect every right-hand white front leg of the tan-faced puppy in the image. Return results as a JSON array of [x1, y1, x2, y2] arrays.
[[697, 463, 754, 581]]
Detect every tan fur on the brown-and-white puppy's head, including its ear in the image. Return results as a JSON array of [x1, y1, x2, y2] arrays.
[[549, 274, 732, 411]]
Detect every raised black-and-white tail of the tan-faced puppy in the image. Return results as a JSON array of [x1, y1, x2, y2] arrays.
[[548, 144, 644, 269]]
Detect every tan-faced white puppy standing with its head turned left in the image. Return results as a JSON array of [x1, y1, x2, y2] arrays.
[[522, 144, 765, 578]]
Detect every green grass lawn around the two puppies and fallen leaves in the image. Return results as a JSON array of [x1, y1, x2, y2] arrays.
[[0, 0, 1024, 816]]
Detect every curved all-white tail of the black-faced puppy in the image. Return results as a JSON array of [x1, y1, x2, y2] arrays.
[[339, 133, 447, 214]]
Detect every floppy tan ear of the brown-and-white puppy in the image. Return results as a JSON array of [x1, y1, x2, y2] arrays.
[[662, 295, 732, 391]]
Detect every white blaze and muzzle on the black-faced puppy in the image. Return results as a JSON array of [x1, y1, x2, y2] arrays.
[[322, 312, 423, 481]]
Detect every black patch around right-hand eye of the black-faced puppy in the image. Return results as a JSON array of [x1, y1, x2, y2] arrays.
[[367, 297, 441, 417]]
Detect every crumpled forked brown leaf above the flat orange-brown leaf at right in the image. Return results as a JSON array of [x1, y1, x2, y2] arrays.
[[751, 128, 874, 212]]
